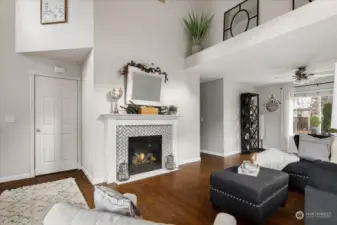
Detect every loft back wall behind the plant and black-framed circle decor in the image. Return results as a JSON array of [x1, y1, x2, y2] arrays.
[[197, 0, 292, 48]]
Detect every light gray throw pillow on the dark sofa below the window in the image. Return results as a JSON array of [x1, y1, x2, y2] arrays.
[[298, 134, 334, 161]]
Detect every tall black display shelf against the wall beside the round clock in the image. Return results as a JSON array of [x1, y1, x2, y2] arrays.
[[241, 93, 262, 153]]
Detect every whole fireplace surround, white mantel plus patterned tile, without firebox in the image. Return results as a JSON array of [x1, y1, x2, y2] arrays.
[[99, 114, 179, 184]]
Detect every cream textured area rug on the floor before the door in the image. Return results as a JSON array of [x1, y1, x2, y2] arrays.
[[0, 178, 88, 225]]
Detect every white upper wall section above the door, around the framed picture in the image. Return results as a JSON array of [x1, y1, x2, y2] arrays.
[[13, 0, 94, 52]]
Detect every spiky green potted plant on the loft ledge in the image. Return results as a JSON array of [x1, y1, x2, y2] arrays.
[[183, 12, 214, 55]]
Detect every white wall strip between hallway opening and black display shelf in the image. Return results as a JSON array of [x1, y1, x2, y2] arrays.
[[223, 79, 256, 155]]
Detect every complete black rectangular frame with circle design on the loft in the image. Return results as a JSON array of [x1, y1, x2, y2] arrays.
[[223, 0, 259, 40]]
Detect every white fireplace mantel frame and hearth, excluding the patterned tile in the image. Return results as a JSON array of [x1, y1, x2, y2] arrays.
[[98, 114, 180, 184]]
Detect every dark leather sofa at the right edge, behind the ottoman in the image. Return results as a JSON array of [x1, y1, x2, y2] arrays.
[[283, 135, 337, 225]]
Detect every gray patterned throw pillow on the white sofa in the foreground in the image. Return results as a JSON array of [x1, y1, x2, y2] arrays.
[[94, 186, 140, 217]]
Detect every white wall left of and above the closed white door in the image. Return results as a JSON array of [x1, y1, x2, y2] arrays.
[[0, 0, 81, 181]]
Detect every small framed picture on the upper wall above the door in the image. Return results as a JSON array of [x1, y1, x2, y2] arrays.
[[40, 0, 67, 24]]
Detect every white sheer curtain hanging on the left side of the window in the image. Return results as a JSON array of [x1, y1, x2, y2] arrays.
[[281, 85, 297, 153]]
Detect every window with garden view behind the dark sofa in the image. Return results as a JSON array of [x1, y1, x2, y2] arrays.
[[293, 92, 335, 134]]
